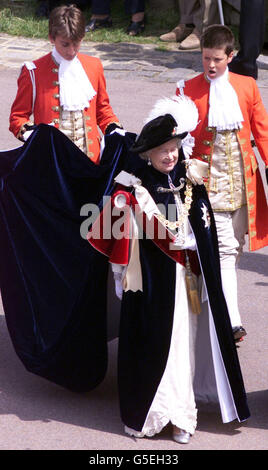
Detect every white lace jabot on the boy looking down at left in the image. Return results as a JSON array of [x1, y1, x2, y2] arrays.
[[52, 47, 96, 111]]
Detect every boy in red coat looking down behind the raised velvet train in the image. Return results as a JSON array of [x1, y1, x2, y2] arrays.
[[10, 5, 121, 162]]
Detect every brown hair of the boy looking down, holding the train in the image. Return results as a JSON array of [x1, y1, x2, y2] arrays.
[[48, 5, 85, 41]]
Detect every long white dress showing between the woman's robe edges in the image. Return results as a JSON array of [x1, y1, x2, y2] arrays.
[[125, 263, 197, 437]]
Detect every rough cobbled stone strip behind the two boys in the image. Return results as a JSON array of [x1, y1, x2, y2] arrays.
[[0, 34, 268, 87]]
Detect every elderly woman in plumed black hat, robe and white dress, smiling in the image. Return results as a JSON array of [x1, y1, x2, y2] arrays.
[[89, 97, 249, 444]]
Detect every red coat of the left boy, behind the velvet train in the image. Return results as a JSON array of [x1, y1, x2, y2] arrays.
[[9, 53, 118, 162]]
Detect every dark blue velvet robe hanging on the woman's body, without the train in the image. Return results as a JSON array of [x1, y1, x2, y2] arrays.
[[110, 163, 249, 431]]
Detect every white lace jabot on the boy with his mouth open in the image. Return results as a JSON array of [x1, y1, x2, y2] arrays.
[[207, 68, 244, 131]]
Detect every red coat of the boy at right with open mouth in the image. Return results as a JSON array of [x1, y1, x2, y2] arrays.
[[176, 72, 268, 251]]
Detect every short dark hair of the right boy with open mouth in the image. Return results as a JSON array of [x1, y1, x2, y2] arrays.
[[200, 24, 235, 56]]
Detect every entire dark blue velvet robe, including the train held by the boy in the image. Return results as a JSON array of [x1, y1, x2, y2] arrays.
[[0, 125, 249, 429]]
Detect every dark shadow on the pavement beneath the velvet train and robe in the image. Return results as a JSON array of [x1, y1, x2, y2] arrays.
[[0, 316, 268, 440]]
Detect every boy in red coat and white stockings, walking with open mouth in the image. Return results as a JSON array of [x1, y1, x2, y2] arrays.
[[176, 25, 268, 340]]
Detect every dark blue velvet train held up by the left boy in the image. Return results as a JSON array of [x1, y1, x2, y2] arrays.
[[0, 125, 133, 391]]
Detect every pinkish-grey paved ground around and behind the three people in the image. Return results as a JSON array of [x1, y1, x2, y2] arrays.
[[0, 34, 268, 456]]
